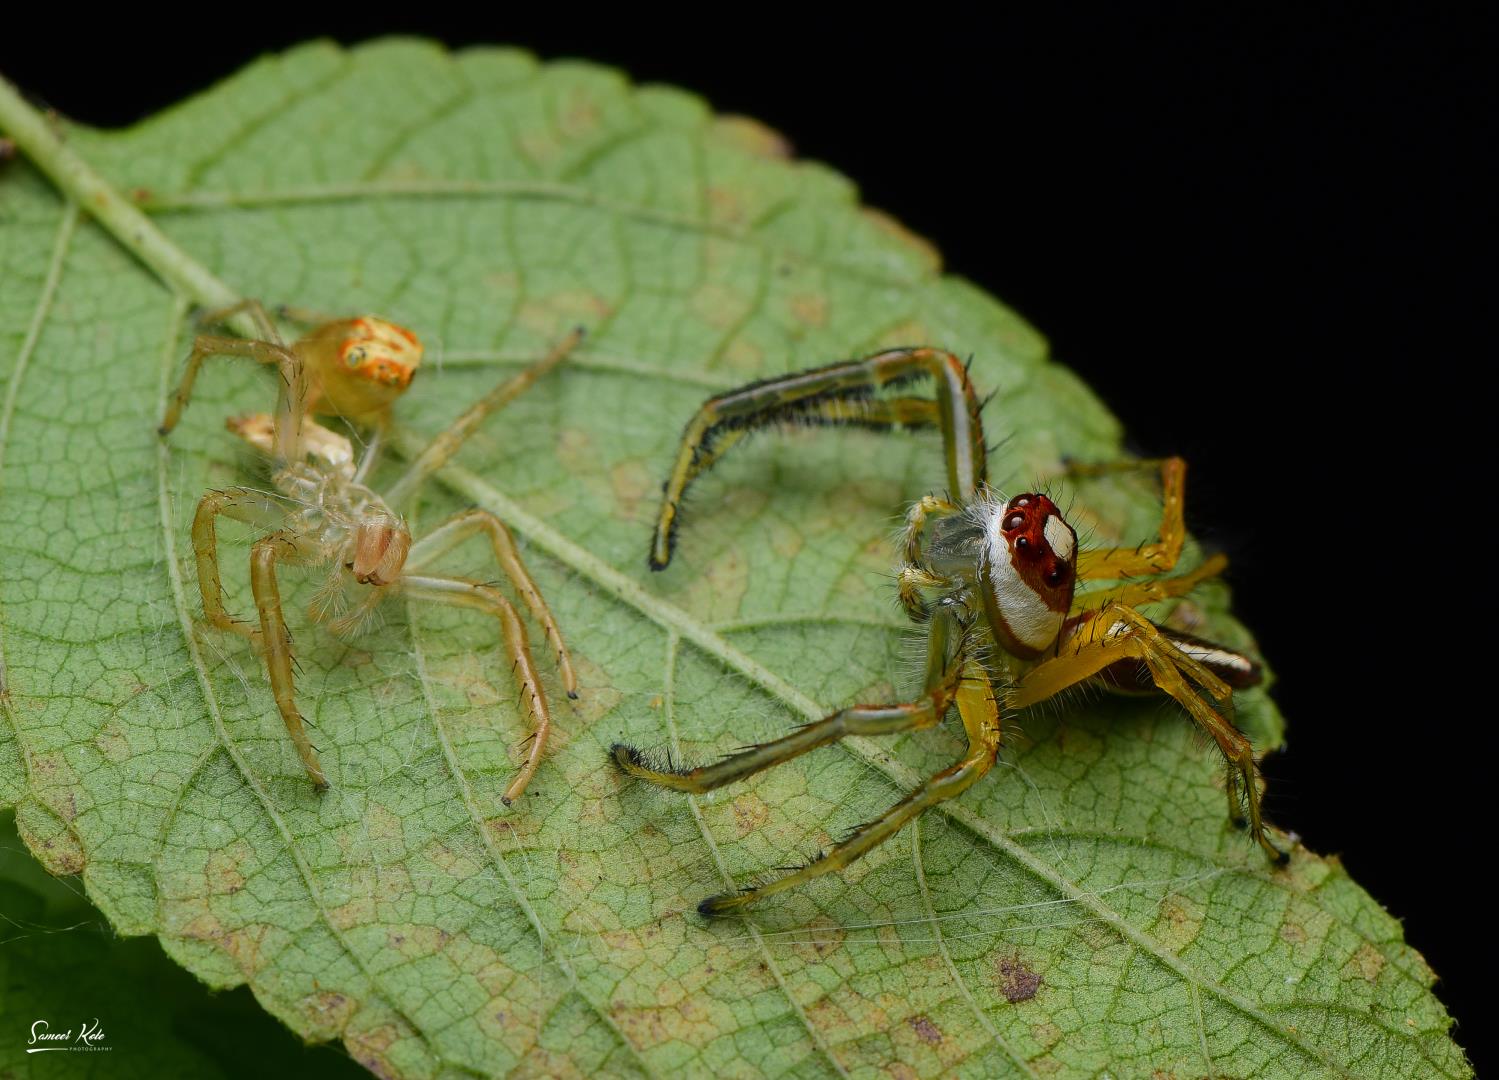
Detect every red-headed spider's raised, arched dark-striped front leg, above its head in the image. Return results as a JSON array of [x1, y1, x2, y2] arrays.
[[651, 348, 986, 570]]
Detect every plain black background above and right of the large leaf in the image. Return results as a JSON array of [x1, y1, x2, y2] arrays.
[[0, 12, 1499, 1073]]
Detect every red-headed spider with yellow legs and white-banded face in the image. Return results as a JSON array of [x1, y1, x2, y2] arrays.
[[613, 348, 1288, 915]]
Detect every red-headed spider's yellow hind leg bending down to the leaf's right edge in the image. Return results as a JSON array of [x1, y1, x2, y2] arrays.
[[1004, 605, 1289, 863]]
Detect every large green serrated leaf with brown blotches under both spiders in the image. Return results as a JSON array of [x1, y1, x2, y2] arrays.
[[0, 42, 1471, 1077]]
